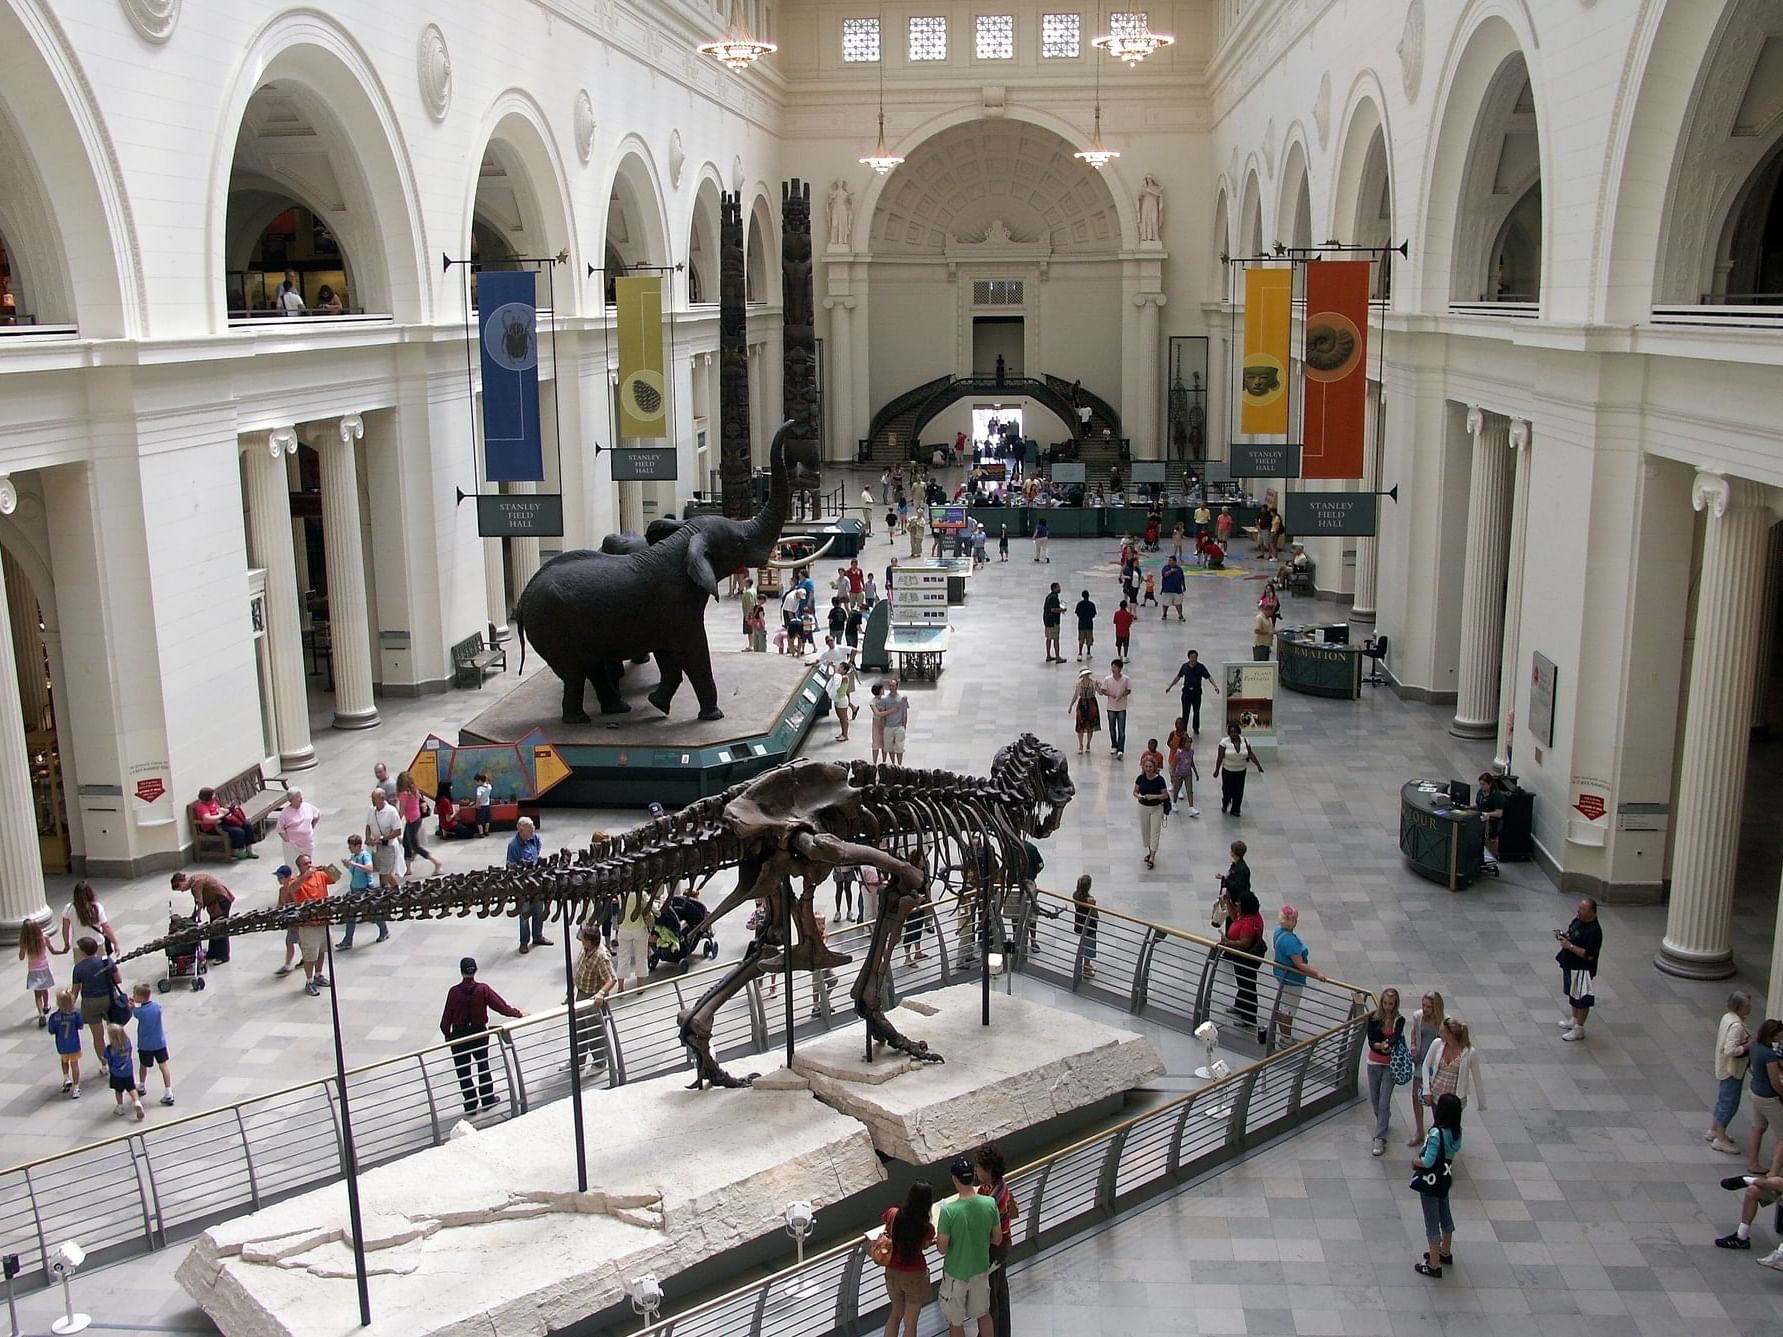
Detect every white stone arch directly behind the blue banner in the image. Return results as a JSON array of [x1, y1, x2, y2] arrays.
[[458, 89, 583, 314]]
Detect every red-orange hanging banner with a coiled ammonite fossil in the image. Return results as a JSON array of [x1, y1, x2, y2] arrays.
[[1300, 260, 1369, 478]]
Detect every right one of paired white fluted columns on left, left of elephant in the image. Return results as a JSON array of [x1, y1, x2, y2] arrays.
[[316, 414, 382, 729]]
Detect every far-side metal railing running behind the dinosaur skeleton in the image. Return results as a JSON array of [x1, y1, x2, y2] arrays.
[[0, 891, 1368, 1285]]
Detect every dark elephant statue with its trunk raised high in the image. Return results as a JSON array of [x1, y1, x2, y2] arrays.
[[514, 422, 829, 724]]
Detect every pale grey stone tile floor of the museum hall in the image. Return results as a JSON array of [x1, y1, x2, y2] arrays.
[[0, 494, 1783, 1337]]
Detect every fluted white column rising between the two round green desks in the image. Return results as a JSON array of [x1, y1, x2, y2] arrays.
[[1450, 406, 1510, 738]]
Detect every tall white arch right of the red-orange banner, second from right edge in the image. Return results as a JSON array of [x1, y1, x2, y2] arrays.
[[1419, 10, 1548, 310]]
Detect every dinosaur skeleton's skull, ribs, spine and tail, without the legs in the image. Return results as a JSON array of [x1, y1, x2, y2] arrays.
[[129, 734, 1070, 963]]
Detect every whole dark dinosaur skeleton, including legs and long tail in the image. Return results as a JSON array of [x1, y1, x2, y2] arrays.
[[119, 734, 1075, 1086]]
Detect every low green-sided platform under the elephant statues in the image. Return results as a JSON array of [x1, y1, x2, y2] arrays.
[[458, 645, 822, 809]]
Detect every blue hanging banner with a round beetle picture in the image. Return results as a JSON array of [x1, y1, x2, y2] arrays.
[[476, 269, 546, 483]]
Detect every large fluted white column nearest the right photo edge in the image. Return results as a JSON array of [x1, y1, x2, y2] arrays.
[[1655, 472, 1776, 979]]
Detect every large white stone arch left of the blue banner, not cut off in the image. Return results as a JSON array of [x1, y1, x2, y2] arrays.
[[207, 11, 435, 323]]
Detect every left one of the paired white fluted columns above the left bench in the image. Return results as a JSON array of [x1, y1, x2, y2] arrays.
[[248, 428, 316, 770]]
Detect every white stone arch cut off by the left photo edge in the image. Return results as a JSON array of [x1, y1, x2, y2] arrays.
[[0, 5, 148, 339]]
